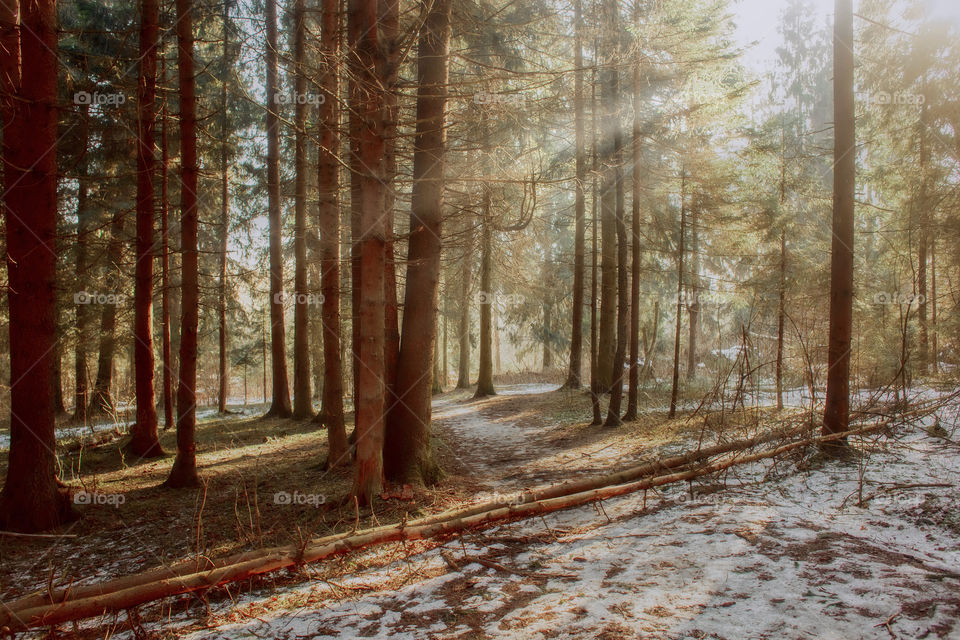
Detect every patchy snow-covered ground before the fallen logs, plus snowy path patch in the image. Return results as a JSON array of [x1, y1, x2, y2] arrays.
[[77, 390, 960, 640]]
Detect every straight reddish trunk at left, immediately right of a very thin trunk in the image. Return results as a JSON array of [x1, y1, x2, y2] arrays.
[[166, 0, 200, 488]]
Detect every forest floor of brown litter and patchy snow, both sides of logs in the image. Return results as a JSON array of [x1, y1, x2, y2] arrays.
[[0, 384, 960, 640]]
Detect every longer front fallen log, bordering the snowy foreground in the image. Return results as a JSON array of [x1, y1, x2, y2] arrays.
[[0, 422, 887, 633]]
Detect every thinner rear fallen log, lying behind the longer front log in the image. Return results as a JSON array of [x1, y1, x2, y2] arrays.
[[0, 418, 810, 616]]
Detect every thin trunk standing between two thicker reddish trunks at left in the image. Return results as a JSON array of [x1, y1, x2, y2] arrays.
[[160, 59, 174, 429]]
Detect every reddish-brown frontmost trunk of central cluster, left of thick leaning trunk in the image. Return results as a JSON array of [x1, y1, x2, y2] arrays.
[[348, 0, 387, 505]]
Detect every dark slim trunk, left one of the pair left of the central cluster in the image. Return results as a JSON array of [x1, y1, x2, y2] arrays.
[[266, 0, 293, 418]]
